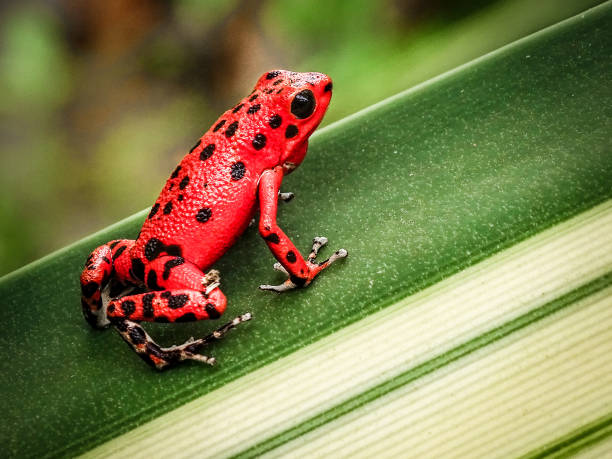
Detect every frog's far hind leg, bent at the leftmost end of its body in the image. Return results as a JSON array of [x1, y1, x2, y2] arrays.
[[81, 239, 135, 328]]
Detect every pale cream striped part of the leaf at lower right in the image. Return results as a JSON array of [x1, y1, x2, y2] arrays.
[[88, 202, 612, 457]]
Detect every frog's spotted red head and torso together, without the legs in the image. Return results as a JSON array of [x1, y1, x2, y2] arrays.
[[130, 70, 331, 270]]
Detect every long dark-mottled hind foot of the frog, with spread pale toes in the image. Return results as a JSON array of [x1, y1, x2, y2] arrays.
[[113, 313, 252, 370]]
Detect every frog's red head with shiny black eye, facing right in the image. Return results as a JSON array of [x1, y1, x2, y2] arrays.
[[256, 70, 332, 174]]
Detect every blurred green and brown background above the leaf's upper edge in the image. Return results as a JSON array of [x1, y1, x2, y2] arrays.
[[0, 0, 601, 275]]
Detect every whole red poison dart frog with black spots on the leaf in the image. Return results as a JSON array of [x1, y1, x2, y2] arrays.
[[80, 70, 347, 370]]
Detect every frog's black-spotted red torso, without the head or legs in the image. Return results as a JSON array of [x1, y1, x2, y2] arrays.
[[132, 95, 282, 269]]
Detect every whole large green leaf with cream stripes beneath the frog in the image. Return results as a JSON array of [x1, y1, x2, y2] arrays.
[[0, 3, 612, 456]]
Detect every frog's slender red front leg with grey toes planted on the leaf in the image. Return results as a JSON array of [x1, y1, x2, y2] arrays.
[[259, 166, 348, 292]]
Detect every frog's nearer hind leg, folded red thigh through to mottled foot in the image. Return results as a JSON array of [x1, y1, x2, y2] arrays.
[[107, 256, 251, 370]]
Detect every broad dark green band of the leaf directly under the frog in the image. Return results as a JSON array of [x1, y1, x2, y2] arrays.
[[0, 3, 612, 456]]
